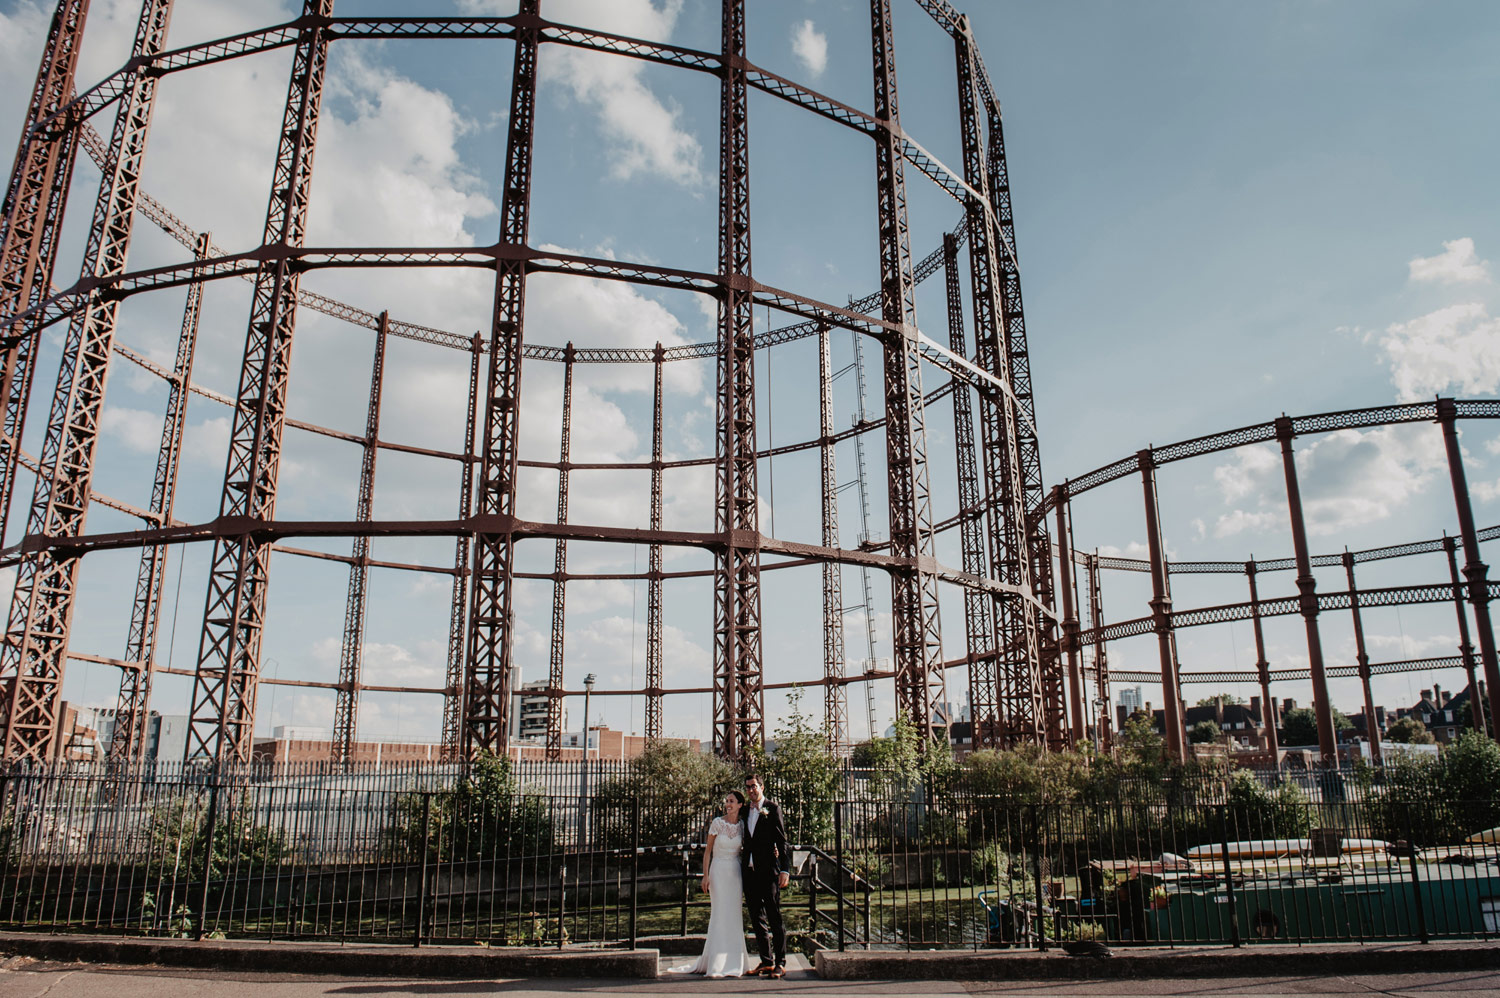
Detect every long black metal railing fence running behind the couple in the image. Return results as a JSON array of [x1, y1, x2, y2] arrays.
[[0, 767, 1500, 950]]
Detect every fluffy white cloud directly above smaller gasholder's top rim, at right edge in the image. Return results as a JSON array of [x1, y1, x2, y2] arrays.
[[1380, 302, 1500, 402]]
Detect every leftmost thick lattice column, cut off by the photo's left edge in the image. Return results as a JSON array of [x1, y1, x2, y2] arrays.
[[0, 0, 89, 543]]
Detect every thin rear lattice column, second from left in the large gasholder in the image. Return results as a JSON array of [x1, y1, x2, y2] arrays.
[[330, 312, 390, 765]]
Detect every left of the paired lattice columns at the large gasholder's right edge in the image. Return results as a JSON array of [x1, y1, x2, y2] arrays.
[[954, 18, 1038, 744]]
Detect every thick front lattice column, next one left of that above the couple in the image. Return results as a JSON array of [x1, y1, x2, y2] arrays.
[[462, 0, 542, 756]]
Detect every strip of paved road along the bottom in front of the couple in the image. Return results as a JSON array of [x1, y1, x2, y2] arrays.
[[0, 957, 1500, 998]]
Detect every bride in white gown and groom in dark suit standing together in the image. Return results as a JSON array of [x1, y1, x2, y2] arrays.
[[677, 774, 792, 977]]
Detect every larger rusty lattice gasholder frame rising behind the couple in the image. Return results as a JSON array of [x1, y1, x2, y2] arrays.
[[0, 0, 1062, 762]]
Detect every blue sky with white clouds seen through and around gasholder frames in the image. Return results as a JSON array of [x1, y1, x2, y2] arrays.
[[0, 0, 1500, 740]]
